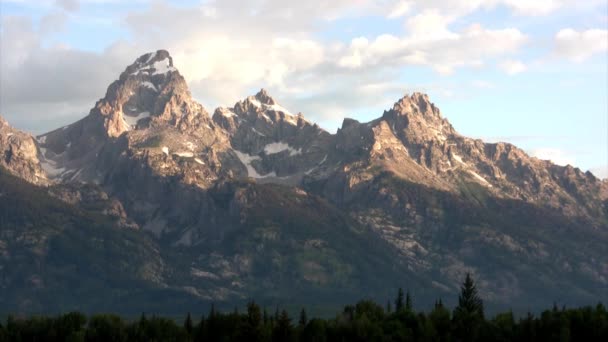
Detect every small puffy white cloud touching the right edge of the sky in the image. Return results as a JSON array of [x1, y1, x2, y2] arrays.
[[554, 28, 608, 62]]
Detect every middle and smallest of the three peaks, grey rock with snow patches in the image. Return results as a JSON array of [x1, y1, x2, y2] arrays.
[[213, 89, 332, 185]]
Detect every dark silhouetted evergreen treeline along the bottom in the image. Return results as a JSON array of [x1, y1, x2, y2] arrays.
[[0, 275, 608, 342]]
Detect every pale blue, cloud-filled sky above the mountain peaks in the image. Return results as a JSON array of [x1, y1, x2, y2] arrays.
[[0, 0, 608, 178]]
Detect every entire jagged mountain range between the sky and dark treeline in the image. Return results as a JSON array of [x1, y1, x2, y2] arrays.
[[0, 50, 608, 313]]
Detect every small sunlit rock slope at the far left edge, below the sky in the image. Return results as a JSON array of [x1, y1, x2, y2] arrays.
[[0, 116, 50, 185]]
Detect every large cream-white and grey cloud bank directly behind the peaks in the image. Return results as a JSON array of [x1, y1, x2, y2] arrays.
[[0, 0, 595, 139]]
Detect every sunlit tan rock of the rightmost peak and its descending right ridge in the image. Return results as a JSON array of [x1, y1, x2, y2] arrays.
[[316, 93, 608, 221]]
